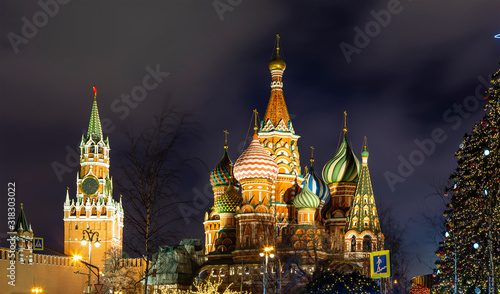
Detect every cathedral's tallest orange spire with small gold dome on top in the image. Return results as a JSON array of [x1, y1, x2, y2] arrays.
[[261, 35, 294, 133]]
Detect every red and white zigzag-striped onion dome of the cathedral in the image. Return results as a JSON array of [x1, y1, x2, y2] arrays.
[[234, 134, 278, 181]]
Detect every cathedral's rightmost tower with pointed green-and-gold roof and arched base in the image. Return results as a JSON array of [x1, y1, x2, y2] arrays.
[[345, 137, 384, 273]]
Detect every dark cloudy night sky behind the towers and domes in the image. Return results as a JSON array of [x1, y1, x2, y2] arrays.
[[0, 0, 500, 275]]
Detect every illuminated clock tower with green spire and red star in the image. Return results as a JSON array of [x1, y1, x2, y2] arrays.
[[64, 87, 123, 265]]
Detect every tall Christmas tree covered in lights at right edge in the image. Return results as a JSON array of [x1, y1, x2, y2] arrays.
[[432, 66, 500, 294]]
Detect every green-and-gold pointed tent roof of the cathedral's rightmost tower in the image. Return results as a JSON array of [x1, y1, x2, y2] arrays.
[[346, 142, 381, 235]]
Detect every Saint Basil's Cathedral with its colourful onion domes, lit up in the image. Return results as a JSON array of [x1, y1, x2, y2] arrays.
[[201, 36, 384, 290]]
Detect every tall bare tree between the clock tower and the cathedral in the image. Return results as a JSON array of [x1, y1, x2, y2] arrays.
[[117, 107, 199, 293]]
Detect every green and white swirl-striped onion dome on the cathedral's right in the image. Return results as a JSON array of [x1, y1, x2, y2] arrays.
[[323, 131, 360, 184]]
